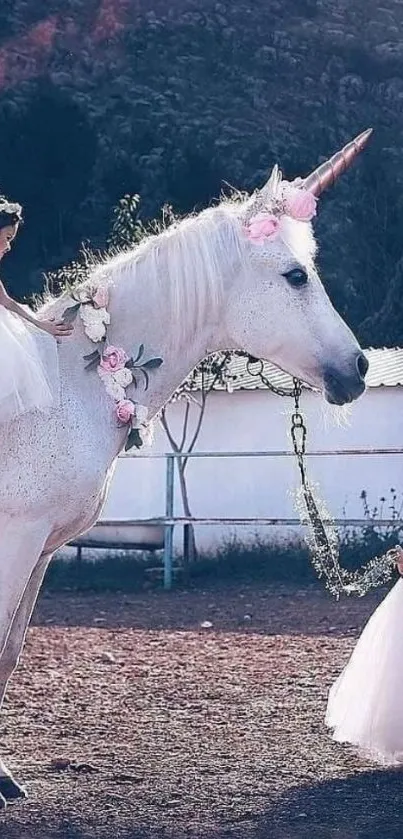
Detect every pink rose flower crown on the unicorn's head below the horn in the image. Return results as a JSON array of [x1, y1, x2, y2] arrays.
[[244, 166, 318, 245]]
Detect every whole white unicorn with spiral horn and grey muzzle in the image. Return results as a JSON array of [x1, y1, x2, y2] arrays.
[[0, 131, 370, 807]]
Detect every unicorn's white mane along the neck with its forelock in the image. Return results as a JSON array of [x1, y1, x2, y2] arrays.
[[48, 198, 316, 339]]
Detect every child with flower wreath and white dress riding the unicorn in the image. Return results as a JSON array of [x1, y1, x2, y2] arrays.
[[0, 198, 72, 423]]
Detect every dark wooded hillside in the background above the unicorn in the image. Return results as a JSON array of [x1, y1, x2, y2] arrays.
[[0, 0, 403, 344]]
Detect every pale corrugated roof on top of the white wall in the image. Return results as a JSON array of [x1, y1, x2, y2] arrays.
[[193, 347, 403, 390]]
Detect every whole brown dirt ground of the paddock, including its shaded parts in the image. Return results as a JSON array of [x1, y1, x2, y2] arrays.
[[0, 585, 403, 839]]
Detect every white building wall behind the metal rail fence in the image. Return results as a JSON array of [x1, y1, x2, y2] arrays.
[[102, 387, 403, 549]]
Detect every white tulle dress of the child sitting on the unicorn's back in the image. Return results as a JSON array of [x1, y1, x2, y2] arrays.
[[0, 305, 58, 423]]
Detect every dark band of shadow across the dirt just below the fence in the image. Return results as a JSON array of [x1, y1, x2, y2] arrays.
[[33, 584, 385, 636]]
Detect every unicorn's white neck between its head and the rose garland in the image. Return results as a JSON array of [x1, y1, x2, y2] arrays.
[[49, 207, 243, 416]]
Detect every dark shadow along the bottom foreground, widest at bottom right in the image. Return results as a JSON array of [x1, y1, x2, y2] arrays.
[[0, 770, 403, 839]]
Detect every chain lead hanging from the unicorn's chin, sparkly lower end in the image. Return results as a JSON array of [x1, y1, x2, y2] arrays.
[[243, 353, 398, 598]]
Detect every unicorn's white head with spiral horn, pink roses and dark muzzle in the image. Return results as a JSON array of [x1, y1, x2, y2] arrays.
[[224, 130, 371, 404]]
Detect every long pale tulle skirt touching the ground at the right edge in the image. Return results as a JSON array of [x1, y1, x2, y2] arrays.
[[326, 579, 403, 765]]
